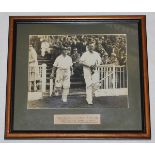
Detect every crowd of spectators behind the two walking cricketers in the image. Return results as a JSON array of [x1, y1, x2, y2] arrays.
[[30, 34, 127, 65]]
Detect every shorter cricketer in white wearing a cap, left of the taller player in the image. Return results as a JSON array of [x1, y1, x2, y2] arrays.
[[51, 47, 73, 102]]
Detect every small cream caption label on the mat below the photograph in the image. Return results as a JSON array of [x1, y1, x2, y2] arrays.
[[54, 114, 101, 124]]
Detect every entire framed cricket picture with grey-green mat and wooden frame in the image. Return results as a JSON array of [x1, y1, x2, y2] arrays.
[[5, 15, 151, 139]]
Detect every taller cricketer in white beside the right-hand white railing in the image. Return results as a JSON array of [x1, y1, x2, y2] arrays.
[[80, 43, 101, 104]]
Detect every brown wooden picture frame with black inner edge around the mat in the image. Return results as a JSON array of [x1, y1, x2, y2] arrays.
[[5, 15, 151, 139]]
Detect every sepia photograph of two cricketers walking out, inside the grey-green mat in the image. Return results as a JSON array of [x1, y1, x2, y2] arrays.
[[27, 34, 130, 109]]
